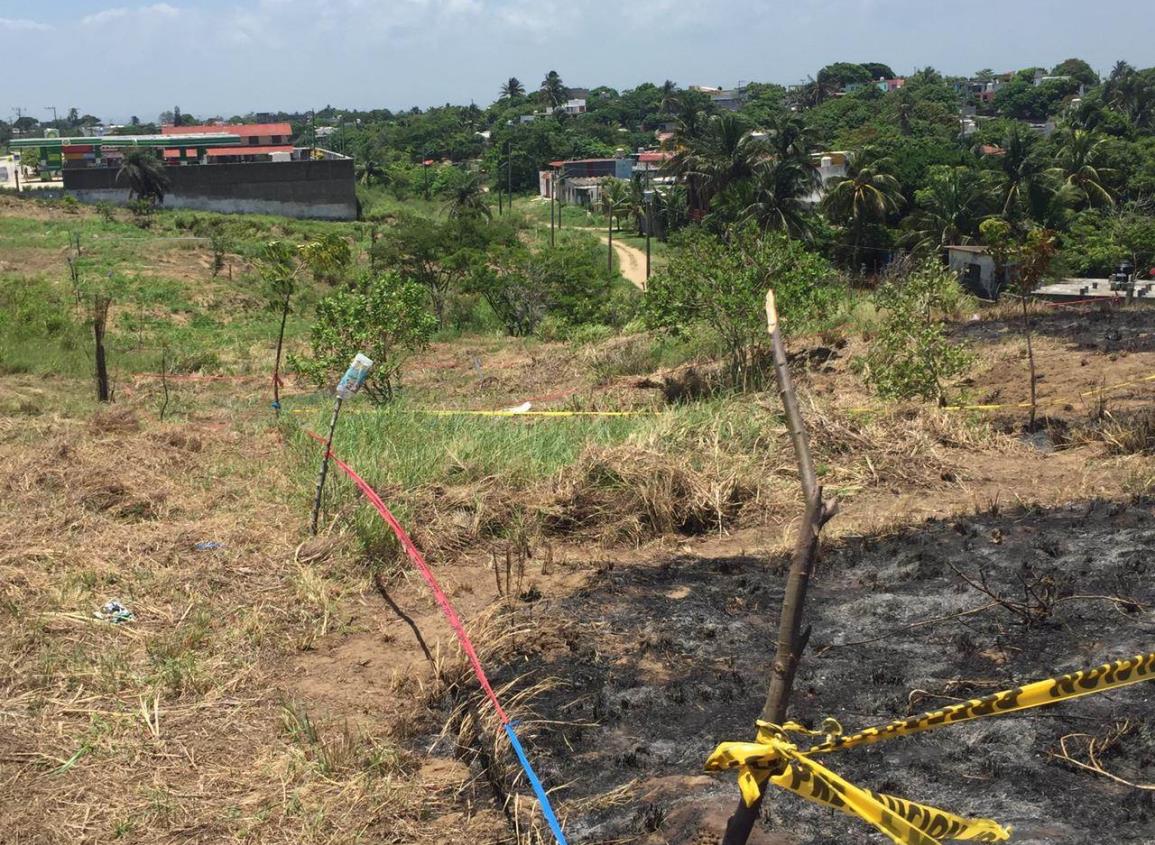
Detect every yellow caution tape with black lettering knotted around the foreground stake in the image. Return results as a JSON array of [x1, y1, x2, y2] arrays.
[[706, 653, 1155, 845]]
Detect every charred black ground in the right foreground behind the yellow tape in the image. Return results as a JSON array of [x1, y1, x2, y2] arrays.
[[485, 502, 1155, 845]]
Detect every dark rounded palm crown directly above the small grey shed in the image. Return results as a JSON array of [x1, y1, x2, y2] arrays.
[[907, 165, 994, 252]]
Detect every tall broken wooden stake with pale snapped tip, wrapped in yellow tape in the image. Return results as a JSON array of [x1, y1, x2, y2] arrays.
[[722, 291, 839, 845]]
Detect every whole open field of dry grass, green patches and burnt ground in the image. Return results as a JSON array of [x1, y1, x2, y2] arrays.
[[0, 191, 1155, 845]]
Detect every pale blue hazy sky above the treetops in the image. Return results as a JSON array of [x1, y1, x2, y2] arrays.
[[0, 0, 1155, 122]]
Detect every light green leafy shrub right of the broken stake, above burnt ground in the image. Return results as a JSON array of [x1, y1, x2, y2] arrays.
[[863, 259, 974, 403]]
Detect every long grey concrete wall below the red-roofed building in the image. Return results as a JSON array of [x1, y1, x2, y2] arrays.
[[65, 158, 357, 220]]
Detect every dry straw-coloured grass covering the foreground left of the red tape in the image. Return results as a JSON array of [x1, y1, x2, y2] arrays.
[[0, 411, 501, 844]]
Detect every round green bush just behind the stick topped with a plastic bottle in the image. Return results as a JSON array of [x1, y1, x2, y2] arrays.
[[289, 274, 437, 402]]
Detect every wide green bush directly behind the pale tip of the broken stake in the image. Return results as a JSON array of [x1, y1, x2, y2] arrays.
[[644, 226, 844, 388]]
